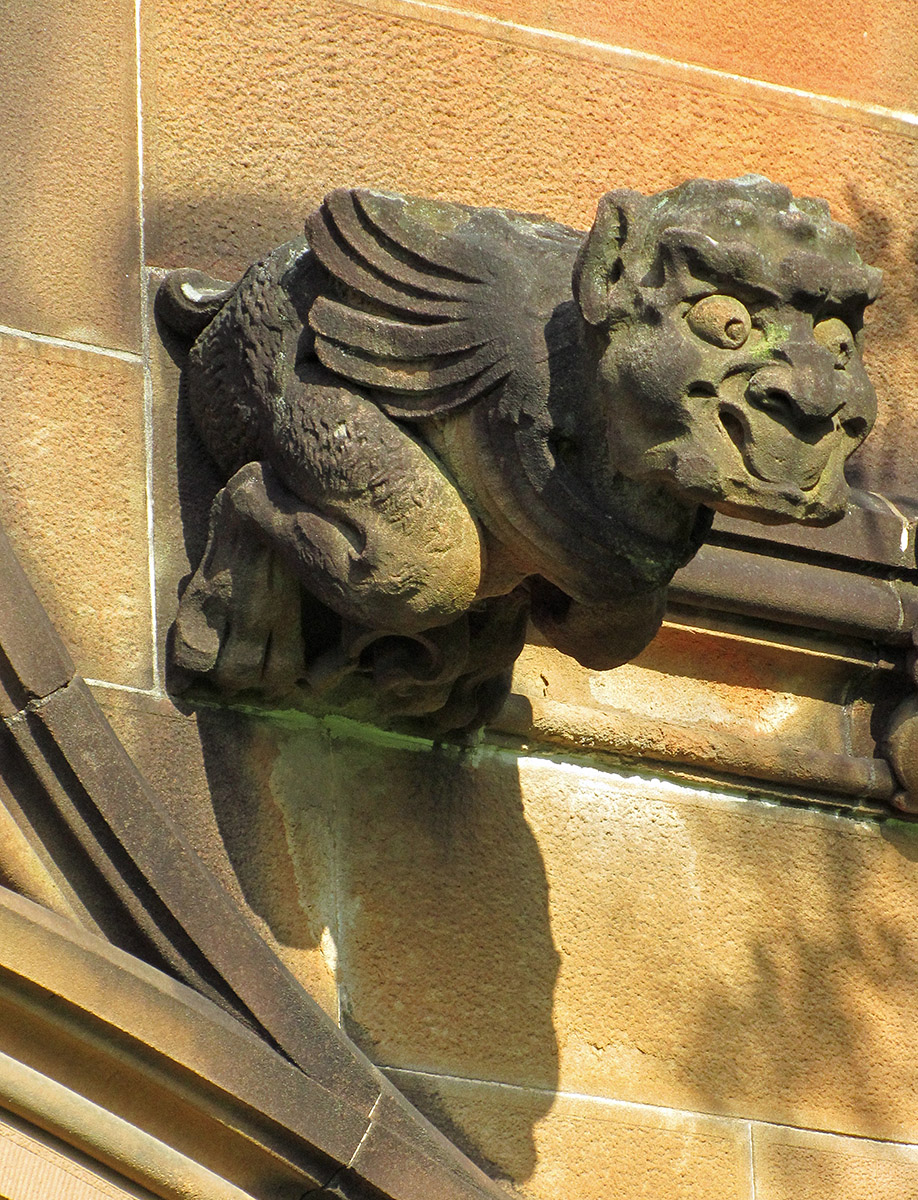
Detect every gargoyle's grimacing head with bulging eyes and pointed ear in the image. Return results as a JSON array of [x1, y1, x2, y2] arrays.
[[574, 176, 880, 524]]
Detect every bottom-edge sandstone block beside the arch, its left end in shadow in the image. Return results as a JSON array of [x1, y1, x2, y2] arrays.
[[391, 1072, 753, 1200]]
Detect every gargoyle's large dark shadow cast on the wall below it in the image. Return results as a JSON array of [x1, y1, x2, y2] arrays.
[[163, 331, 558, 1183]]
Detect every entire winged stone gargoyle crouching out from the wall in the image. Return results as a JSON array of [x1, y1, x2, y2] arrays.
[[157, 176, 880, 736]]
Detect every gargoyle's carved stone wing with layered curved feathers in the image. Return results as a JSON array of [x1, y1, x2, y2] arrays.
[[306, 188, 583, 420]]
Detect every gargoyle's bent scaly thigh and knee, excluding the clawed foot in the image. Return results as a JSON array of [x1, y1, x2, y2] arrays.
[[227, 384, 484, 634]]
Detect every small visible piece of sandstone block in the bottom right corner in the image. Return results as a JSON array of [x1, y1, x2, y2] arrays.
[[752, 1126, 918, 1200]]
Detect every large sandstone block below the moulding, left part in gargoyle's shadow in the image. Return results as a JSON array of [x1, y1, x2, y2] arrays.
[[323, 729, 918, 1140]]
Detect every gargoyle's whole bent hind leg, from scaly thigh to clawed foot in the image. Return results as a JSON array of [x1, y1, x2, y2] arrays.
[[173, 386, 482, 692]]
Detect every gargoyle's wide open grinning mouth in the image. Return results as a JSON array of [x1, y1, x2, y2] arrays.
[[718, 402, 832, 492]]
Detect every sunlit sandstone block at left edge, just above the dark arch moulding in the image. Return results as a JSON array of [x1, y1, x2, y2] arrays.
[[0, 336, 152, 688]]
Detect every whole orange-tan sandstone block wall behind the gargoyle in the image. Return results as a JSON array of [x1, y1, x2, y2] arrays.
[[0, 0, 918, 1200]]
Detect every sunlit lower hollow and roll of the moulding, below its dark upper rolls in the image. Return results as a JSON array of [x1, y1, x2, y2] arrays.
[[493, 624, 908, 811]]
